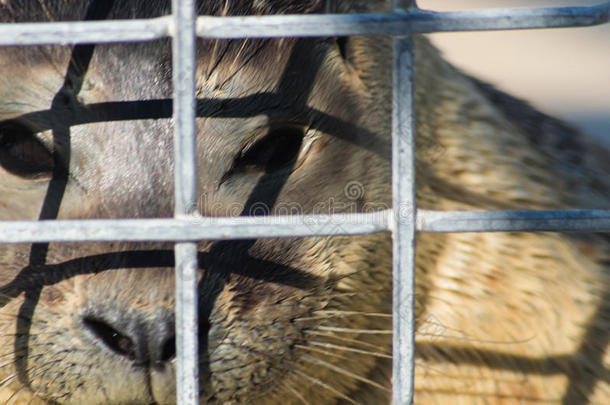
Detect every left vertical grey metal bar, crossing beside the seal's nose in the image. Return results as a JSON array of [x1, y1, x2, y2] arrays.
[[172, 0, 199, 405]]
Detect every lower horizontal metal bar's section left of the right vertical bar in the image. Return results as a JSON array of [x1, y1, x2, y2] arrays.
[[0, 211, 390, 243]]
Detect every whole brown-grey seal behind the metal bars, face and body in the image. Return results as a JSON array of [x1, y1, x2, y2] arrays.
[[0, 0, 610, 405]]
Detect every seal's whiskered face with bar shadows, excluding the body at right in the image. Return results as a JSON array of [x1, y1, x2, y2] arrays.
[[0, 0, 390, 404]]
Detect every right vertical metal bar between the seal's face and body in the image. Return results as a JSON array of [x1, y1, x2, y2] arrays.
[[392, 0, 416, 405]]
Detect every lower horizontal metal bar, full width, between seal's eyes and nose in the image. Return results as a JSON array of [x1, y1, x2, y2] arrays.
[[0, 210, 610, 243]]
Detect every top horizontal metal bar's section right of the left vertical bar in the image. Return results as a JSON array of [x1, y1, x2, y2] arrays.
[[197, 2, 610, 39]]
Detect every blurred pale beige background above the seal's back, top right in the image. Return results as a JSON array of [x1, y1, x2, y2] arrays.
[[418, 0, 610, 145]]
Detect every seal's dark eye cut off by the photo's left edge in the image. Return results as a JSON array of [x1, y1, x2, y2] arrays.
[[0, 123, 55, 178]]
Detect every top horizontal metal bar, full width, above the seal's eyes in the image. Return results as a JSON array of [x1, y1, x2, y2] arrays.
[[0, 2, 610, 45]]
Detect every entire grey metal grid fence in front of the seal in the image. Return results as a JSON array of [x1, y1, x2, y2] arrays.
[[0, 0, 610, 404]]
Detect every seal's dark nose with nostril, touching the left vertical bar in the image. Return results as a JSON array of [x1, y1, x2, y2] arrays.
[[82, 310, 176, 367]]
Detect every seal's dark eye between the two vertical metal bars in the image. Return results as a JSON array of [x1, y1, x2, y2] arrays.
[[230, 127, 304, 174]]
